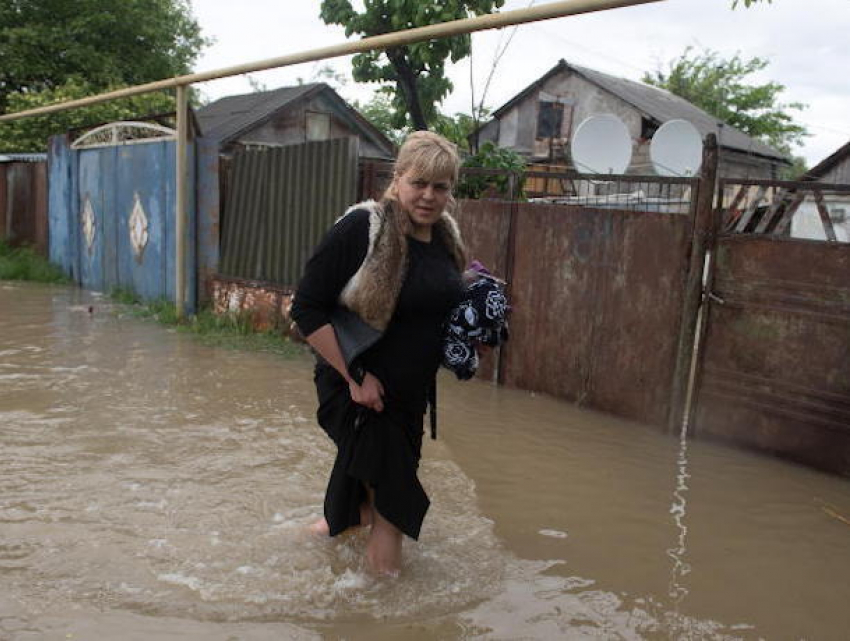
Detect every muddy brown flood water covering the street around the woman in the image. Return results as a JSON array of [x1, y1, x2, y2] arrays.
[[0, 282, 850, 641]]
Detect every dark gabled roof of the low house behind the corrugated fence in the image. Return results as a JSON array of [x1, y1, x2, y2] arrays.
[[196, 82, 393, 157]]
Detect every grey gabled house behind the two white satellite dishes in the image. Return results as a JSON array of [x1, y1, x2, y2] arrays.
[[472, 60, 791, 179]]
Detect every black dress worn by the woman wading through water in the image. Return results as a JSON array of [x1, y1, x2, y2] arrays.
[[292, 209, 465, 539]]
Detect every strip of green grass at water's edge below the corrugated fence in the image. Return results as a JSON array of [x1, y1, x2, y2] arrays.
[[110, 288, 305, 358]]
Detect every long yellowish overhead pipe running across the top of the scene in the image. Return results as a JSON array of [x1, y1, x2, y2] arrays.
[[0, 0, 664, 122]]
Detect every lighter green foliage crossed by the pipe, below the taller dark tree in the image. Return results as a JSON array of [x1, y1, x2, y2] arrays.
[[0, 79, 175, 152]]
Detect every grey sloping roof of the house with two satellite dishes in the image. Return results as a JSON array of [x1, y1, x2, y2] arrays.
[[486, 59, 788, 163]]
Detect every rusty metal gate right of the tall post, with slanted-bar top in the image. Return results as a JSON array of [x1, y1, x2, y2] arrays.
[[691, 181, 850, 475]]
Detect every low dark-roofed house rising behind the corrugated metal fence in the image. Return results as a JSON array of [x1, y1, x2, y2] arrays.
[[196, 82, 395, 160]]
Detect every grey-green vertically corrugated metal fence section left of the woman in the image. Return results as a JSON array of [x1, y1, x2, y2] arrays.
[[220, 138, 358, 285]]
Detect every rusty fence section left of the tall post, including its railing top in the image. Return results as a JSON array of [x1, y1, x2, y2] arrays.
[[324, 158, 713, 428]]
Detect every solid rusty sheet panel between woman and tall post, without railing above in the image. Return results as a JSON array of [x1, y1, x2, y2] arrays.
[[458, 188, 695, 427]]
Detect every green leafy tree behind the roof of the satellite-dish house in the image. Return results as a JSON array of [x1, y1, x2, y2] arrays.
[[643, 47, 809, 153]]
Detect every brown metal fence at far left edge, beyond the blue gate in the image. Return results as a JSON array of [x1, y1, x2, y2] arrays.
[[0, 162, 48, 256]]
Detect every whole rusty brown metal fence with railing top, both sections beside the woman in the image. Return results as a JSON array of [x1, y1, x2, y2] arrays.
[[219, 143, 850, 474]]
